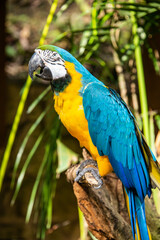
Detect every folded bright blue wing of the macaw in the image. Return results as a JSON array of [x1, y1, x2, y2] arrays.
[[83, 83, 151, 202]]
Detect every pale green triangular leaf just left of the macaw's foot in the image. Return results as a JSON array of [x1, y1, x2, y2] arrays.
[[57, 139, 78, 173]]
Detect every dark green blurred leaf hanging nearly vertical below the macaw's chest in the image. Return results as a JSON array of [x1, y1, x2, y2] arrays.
[[37, 117, 60, 239]]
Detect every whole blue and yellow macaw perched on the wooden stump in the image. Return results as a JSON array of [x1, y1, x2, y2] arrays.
[[29, 45, 160, 240]]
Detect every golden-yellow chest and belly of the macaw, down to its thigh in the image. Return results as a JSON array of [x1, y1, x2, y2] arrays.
[[54, 62, 112, 175]]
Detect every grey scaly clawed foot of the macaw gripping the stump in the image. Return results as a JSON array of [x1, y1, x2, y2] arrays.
[[75, 159, 103, 189]]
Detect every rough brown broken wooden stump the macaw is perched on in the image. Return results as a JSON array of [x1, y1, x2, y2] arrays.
[[67, 162, 133, 240]]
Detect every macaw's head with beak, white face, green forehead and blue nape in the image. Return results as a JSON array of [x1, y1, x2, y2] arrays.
[[29, 45, 86, 91]]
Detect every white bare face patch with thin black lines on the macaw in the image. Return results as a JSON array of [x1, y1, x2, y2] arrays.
[[35, 49, 67, 80]]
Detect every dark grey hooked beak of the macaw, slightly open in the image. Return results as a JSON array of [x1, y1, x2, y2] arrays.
[[28, 53, 52, 81]]
